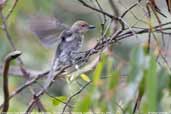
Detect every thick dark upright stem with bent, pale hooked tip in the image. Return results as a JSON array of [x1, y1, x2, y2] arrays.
[[2, 51, 21, 112]]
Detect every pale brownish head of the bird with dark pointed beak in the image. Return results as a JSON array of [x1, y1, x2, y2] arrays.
[[71, 20, 95, 33]]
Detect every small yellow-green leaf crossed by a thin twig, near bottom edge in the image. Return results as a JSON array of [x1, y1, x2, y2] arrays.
[[52, 96, 67, 106]]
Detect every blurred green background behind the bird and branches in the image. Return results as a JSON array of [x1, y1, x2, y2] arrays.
[[0, 0, 171, 114]]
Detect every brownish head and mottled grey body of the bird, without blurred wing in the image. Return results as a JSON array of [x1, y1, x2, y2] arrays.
[[53, 20, 95, 69]]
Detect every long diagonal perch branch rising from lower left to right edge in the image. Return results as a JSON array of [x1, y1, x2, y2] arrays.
[[0, 22, 171, 108]]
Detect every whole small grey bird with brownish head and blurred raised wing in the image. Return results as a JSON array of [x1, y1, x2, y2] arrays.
[[30, 16, 95, 75]]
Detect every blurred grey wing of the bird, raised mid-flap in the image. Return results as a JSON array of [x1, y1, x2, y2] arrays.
[[30, 15, 69, 47]]
